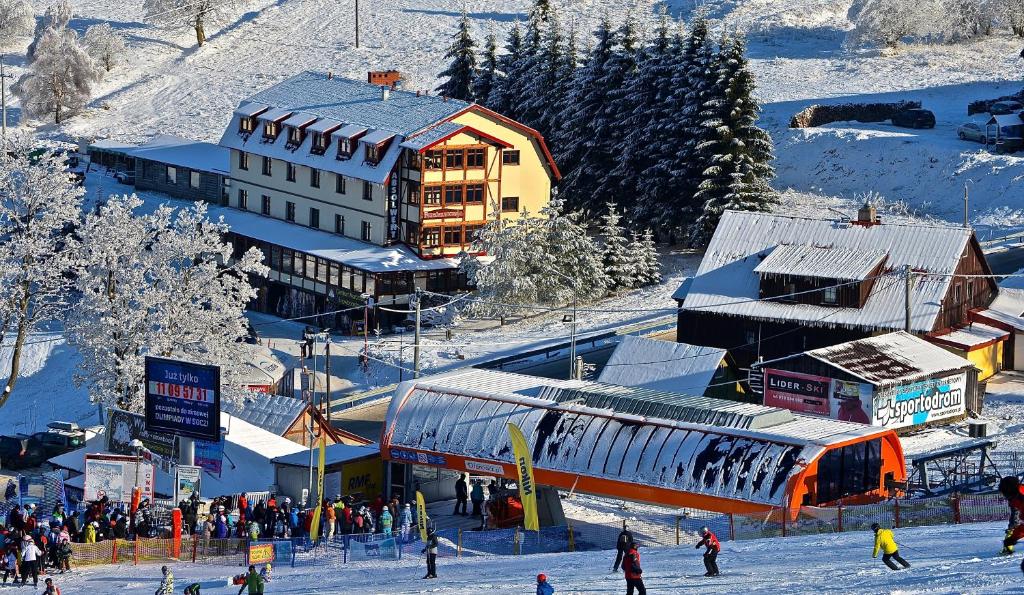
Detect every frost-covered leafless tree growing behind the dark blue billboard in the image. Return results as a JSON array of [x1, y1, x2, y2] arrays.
[[67, 196, 266, 412]]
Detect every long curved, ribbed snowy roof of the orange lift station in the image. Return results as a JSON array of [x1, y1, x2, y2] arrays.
[[382, 370, 888, 505]]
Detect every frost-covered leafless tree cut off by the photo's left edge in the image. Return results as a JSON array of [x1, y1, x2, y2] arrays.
[[0, 136, 85, 407]]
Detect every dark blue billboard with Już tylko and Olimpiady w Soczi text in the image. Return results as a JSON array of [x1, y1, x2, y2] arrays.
[[145, 357, 220, 440]]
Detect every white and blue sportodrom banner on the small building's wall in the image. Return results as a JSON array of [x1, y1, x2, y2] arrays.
[[872, 374, 967, 428]]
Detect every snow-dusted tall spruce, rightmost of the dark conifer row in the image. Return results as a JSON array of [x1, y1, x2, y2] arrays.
[[692, 36, 778, 246]]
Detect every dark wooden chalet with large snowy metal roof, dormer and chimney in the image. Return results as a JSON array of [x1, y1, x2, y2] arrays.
[[674, 205, 1009, 379]]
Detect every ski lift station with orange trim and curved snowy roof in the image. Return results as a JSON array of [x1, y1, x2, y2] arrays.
[[381, 370, 906, 522]]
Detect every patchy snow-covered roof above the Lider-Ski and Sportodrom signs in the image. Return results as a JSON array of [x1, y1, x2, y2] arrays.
[[790, 331, 974, 385]]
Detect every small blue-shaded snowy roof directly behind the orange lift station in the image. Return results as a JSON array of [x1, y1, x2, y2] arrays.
[[597, 335, 725, 394]]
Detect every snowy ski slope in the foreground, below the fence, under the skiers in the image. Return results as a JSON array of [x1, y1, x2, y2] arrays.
[[39, 523, 1024, 595]]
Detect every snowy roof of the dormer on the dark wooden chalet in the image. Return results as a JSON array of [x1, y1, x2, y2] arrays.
[[754, 244, 886, 281]]
